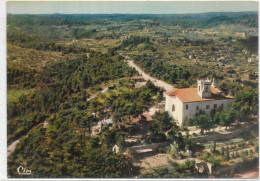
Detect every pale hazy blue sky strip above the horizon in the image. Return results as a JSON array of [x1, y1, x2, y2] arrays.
[[7, 1, 258, 14]]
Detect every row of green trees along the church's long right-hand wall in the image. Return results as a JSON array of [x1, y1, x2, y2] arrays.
[[191, 86, 258, 134]]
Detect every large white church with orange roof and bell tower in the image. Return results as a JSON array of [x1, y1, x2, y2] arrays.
[[165, 80, 233, 125]]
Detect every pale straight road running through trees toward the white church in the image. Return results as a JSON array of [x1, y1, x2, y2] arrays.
[[127, 60, 174, 91]]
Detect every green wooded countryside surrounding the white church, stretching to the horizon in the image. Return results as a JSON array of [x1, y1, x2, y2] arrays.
[[7, 12, 259, 178]]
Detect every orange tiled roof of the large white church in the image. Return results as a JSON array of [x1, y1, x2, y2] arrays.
[[166, 86, 231, 103]]
